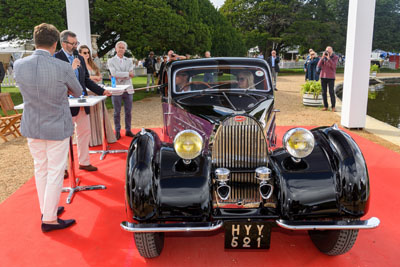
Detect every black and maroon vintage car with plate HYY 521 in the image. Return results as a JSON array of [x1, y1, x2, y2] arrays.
[[121, 58, 379, 258]]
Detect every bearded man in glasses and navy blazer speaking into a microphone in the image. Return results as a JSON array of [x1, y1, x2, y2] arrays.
[[55, 30, 111, 171]]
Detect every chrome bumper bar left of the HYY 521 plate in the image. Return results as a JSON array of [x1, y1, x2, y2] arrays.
[[120, 221, 224, 233]]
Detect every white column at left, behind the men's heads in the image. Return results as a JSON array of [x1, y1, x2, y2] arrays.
[[65, 0, 92, 51]]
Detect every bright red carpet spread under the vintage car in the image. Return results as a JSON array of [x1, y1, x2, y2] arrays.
[[0, 127, 400, 267]]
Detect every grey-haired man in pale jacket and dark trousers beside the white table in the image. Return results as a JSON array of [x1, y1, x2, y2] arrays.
[[107, 41, 134, 139]]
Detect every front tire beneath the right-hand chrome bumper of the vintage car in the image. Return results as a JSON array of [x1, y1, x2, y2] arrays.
[[308, 229, 358, 256]]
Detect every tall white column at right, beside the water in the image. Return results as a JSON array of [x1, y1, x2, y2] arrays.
[[341, 0, 375, 128]]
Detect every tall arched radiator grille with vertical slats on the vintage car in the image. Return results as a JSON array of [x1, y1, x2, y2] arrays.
[[211, 116, 274, 208]]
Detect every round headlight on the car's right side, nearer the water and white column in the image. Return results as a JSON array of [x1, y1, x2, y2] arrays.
[[283, 128, 315, 158]]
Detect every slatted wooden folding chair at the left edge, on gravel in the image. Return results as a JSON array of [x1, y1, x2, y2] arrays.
[[0, 93, 22, 142]]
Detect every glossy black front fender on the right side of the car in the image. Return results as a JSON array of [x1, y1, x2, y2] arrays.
[[270, 127, 369, 219]]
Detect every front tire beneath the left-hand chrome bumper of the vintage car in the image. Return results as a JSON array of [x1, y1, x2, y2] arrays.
[[133, 233, 164, 259]]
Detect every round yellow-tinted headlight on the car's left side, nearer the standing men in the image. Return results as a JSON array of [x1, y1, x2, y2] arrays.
[[174, 130, 203, 159]]
